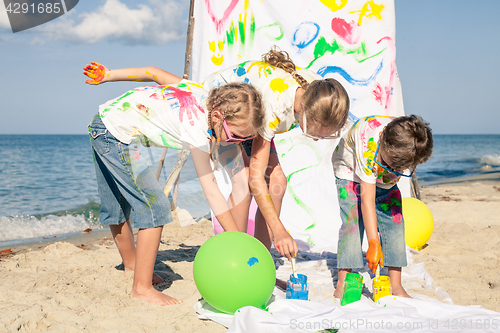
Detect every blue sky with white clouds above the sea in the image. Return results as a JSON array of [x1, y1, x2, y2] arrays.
[[0, 0, 500, 134]]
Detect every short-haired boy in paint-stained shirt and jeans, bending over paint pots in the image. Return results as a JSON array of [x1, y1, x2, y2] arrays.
[[332, 115, 433, 298]]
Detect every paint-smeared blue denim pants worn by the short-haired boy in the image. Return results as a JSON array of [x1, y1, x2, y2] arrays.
[[335, 178, 407, 268]]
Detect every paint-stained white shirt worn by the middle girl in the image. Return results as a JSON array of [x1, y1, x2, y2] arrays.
[[203, 61, 323, 141]]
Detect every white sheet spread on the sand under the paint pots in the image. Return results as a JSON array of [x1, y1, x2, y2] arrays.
[[194, 247, 500, 333]]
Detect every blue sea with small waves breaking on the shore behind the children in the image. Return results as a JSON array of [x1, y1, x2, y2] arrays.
[[0, 135, 500, 247]]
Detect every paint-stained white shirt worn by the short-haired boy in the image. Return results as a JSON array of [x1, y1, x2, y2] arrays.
[[332, 116, 400, 188]]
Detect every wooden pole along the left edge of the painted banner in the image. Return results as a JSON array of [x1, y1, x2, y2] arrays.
[[164, 0, 194, 211]]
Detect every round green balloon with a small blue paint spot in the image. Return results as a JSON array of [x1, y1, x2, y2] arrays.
[[193, 231, 276, 314]]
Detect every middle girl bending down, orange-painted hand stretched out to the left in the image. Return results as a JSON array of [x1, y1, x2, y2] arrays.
[[84, 49, 349, 259]]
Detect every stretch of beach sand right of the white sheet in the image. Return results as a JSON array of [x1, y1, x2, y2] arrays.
[[414, 173, 500, 312]]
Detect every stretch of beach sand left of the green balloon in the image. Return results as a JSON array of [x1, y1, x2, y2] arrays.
[[0, 211, 227, 333]]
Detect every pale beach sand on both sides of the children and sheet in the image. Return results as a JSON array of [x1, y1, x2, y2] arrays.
[[0, 173, 500, 333]]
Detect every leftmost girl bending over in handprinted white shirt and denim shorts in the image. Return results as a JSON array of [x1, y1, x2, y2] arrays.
[[88, 80, 264, 305]]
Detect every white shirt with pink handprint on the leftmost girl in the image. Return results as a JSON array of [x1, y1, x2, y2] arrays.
[[99, 80, 209, 152]]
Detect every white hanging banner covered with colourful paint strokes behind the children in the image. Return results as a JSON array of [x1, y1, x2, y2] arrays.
[[192, 0, 404, 250]]
